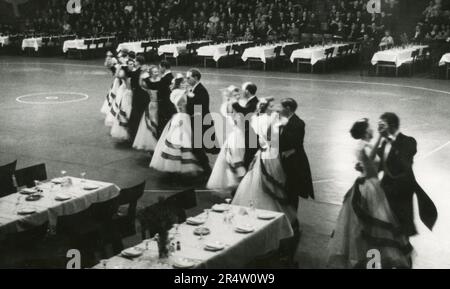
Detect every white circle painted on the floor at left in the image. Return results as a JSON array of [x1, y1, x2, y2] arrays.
[[16, 91, 89, 104]]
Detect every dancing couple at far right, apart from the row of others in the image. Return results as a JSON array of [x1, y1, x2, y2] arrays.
[[328, 113, 437, 269]]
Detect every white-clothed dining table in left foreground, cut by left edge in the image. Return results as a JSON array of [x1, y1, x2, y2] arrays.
[[0, 177, 120, 240]]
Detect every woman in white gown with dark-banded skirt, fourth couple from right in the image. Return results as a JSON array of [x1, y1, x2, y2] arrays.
[[150, 74, 203, 176]]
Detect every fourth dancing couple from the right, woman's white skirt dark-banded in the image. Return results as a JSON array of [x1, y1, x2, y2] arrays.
[[150, 69, 218, 177]]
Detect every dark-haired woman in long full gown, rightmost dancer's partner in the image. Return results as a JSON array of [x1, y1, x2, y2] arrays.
[[328, 119, 413, 269]]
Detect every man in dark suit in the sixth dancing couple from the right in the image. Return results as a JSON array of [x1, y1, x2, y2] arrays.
[[129, 55, 150, 143]]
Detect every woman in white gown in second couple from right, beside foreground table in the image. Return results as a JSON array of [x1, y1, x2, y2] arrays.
[[232, 99, 297, 223]]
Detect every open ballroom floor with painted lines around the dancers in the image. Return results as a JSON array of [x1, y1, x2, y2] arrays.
[[0, 56, 450, 268]]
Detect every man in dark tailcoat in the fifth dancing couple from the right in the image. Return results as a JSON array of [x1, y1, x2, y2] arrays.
[[144, 60, 177, 137]]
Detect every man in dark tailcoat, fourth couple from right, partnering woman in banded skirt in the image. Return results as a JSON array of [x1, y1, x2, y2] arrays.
[[186, 69, 220, 176]]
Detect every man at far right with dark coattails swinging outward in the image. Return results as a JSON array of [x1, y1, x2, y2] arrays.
[[378, 113, 437, 236]]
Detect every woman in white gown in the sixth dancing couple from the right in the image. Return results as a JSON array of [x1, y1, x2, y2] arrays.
[[111, 67, 133, 141]]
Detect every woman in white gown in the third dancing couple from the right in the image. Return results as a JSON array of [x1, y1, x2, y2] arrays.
[[206, 86, 246, 196]]
